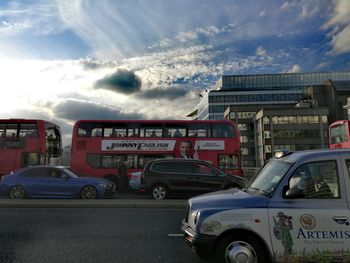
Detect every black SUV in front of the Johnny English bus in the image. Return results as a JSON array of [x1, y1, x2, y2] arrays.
[[140, 159, 246, 199]]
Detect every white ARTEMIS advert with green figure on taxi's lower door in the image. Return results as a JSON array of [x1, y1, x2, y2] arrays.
[[273, 212, 350, 262]]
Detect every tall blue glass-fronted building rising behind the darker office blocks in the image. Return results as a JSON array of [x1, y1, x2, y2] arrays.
[[193, 71, 350, 120]]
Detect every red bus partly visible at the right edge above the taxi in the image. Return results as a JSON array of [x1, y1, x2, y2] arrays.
[[328, 120, 350, 149]]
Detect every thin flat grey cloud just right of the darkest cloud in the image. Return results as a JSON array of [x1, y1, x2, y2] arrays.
[[137, 87, 189, 100]]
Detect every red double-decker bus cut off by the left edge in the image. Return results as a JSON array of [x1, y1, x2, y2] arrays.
[[0, 119, 62, 175]]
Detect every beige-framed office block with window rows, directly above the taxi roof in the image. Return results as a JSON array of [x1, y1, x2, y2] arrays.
[[255, 107, 329, 167]]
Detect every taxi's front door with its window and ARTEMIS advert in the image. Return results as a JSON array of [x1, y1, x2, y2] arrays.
[[269, 159, 350, 262]]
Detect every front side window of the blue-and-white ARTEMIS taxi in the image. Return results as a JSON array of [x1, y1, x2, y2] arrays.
[[289, 161, 340, 199]]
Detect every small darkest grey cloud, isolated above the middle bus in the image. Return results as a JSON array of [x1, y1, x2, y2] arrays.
[[94, 70, 141, 94]]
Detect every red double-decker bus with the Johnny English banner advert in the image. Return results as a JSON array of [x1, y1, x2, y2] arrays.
[[71, 120, 242, 186]]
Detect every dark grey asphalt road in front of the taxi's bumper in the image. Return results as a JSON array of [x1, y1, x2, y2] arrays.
[[0, 208, 202, 263]]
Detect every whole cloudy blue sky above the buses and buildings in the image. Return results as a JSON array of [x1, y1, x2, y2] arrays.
[[0, 0, 350, 145]]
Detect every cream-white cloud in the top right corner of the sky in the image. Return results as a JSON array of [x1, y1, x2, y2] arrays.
[[322, 0, 350, 55]]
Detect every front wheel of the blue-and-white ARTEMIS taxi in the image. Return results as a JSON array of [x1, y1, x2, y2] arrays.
[[215, 234, 269, 263]]
